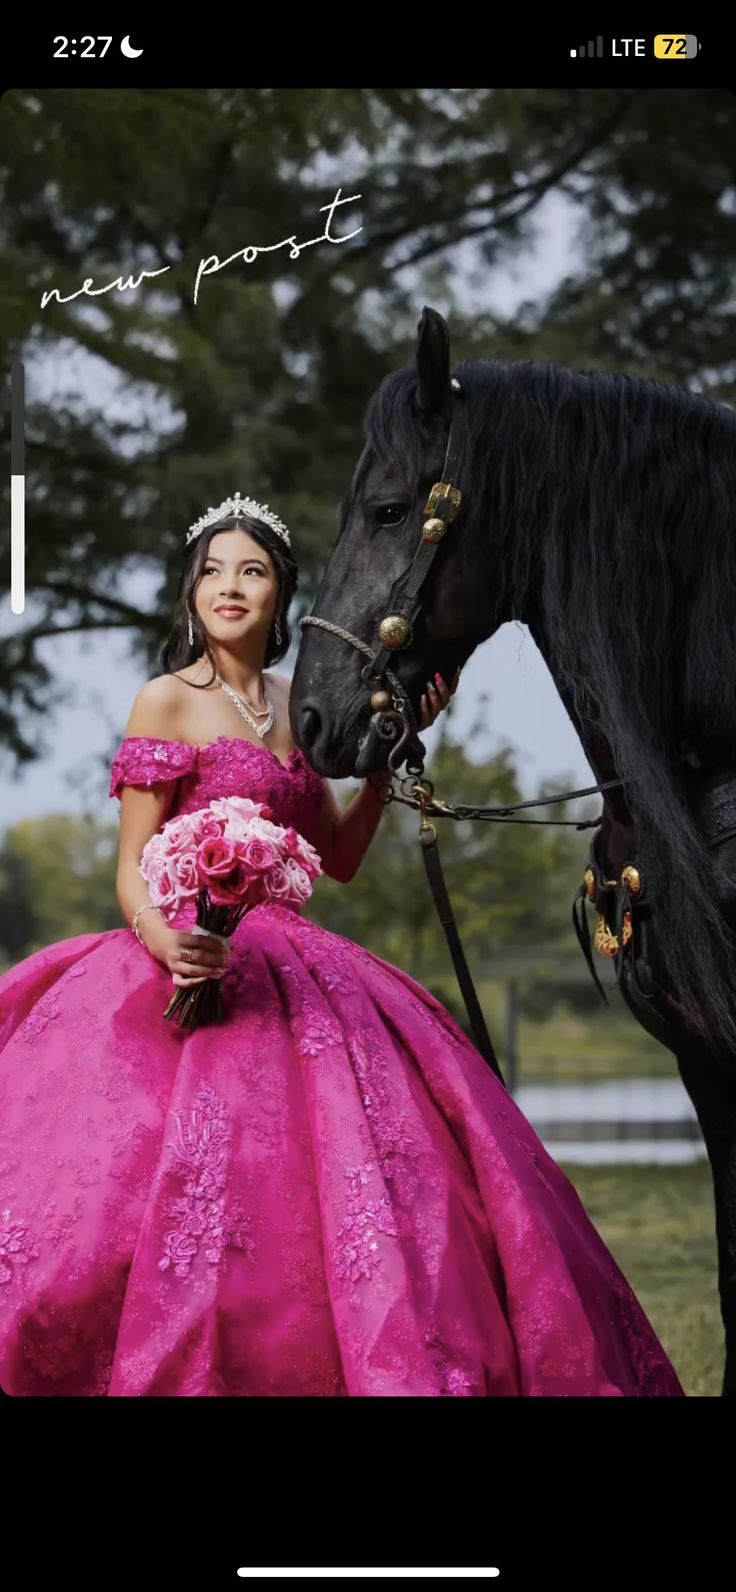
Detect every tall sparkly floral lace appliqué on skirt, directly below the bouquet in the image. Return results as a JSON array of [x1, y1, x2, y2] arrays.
[[158, 1083, 255, 1278]]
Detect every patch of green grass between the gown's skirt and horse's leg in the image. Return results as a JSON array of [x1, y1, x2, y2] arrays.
[[564, 1164, 723, 1398]]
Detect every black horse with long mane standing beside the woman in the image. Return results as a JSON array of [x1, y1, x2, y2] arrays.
[[290, 300, 736, 1395]]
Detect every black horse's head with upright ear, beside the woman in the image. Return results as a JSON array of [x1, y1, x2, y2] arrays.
[[292, 309, 500, 778]]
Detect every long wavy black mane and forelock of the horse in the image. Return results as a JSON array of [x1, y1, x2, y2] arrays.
[[368, 360, 736, 1055]]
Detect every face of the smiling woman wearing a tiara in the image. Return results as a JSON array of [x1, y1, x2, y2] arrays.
[[194, 530, 279, 651]]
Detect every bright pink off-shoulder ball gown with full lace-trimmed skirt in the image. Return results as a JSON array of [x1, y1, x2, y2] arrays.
[[0, 736, 683, 1398]]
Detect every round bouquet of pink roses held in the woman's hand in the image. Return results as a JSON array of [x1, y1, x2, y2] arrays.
[[139, 796, 323, 1028]]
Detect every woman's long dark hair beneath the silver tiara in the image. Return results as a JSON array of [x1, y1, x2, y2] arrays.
[[161, 514, 299, 689]]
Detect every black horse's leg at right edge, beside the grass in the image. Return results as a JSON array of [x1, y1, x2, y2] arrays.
[[677, 1049, 736, 1398]]
